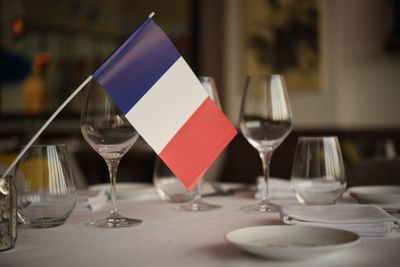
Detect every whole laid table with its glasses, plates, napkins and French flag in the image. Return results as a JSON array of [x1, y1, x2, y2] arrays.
[[0, 13, 400, 267]]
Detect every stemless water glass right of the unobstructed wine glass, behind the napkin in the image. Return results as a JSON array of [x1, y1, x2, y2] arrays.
[[291, 136, 346, 205]]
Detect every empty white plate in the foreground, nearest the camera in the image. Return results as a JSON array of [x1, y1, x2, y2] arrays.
[[225, 225, 360, 260]]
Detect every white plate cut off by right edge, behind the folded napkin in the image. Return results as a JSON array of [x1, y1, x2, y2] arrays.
[[348, 185, 400, 207]]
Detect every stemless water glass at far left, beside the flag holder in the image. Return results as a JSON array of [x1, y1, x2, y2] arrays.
[[16, 145, 77, 228]]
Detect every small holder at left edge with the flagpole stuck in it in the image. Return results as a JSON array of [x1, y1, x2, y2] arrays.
[[0, 175, 17, 251]]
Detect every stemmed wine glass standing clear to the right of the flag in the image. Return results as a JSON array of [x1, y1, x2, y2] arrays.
[[240, 74, 292, 212]]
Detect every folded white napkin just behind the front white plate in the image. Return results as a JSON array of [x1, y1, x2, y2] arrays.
[[280, 204, 400, 236]]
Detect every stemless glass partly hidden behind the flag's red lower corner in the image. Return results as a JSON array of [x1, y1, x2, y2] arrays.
[[153, 158, 194, 203]]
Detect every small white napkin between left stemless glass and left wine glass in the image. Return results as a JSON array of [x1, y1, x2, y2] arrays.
[[75, 190, 108, 212]]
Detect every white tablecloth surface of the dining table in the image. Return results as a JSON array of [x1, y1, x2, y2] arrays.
[[0, 180, 400, 267]]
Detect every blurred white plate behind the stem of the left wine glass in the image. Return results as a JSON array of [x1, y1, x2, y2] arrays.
[[89, 182, 155, 199]]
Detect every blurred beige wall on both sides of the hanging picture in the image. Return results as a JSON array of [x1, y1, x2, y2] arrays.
[[222, 0, 400, 129]]
